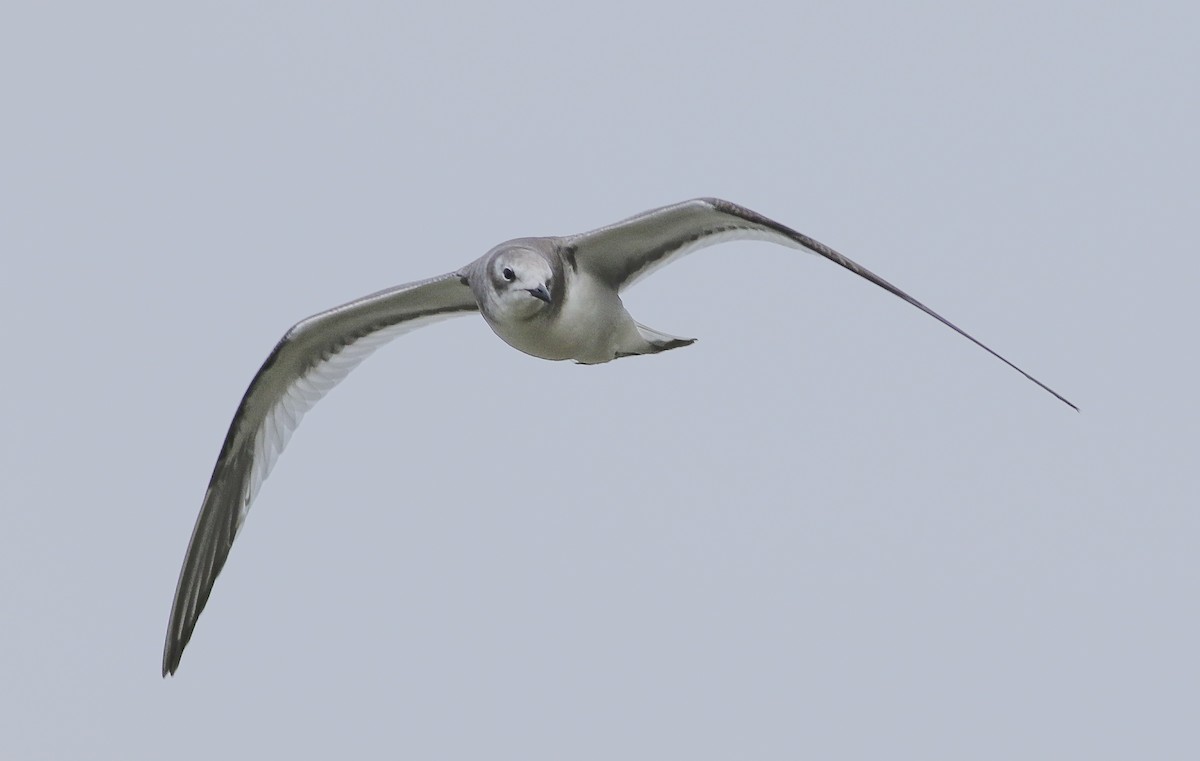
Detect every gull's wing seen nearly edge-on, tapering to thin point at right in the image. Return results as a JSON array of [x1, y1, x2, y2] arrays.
[[559, 198, 1079, 411]]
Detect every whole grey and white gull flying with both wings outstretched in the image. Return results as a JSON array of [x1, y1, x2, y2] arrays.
[[162, 198, 1078, 676]]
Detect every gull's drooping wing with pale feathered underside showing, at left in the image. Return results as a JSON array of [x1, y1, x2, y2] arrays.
[[162, 274, 478, 676]]
